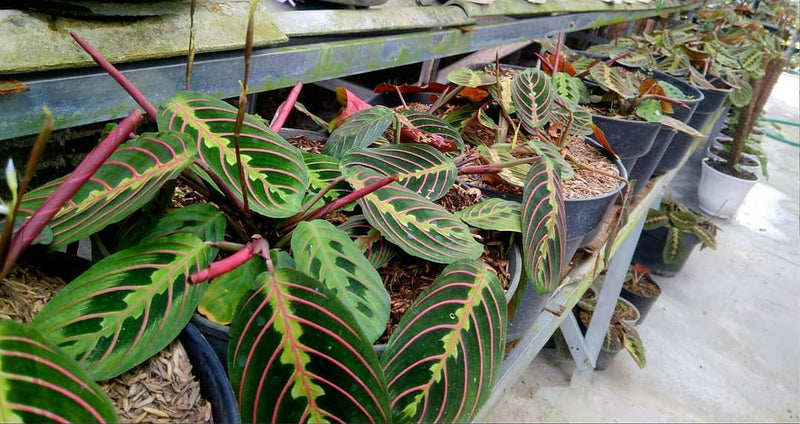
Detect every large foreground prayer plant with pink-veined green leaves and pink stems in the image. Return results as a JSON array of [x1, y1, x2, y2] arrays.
[[0, 21, 565, 422]]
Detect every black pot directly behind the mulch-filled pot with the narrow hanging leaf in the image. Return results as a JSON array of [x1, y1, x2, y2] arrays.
[[592, 115, 661, 173]]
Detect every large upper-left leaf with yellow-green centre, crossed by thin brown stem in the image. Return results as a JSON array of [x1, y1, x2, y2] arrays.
[[158, 92, 308, 218]]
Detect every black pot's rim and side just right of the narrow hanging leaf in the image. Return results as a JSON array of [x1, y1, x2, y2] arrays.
[[564, 138, 628, 259]]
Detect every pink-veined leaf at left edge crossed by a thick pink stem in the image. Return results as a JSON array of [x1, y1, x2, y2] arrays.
[[20, 132, 195, 249]]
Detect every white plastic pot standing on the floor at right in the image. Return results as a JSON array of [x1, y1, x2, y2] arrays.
[[697, 158, 758, 218]]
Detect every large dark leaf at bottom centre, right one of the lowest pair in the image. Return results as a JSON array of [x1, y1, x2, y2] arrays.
[[381, 260, 507, 422]]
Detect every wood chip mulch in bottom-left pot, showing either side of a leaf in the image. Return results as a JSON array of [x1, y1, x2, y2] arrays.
[[0, 264, 212, 423]]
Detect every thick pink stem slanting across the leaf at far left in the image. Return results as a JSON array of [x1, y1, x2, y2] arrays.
[[3, 109, 142, 274]]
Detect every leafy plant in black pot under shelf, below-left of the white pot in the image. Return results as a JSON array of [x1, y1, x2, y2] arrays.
[[633, 199, 719, 277]]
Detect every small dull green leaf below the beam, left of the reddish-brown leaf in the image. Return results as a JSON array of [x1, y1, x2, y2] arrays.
[[322, 105, 394, 158]]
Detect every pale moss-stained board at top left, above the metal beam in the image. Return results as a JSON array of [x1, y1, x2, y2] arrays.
[[0, 0, 288, 74]]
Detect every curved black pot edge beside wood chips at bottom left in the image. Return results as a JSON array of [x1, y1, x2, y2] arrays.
[[179, 323, 242, 424]]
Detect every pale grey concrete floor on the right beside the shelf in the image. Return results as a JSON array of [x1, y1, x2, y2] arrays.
[[490, 74, 800, 422]]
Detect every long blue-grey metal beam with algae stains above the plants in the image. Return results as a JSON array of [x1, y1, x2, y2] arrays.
[[0, 2, 698, 140]]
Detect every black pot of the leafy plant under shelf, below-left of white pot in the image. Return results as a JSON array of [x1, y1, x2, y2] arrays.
[[631, 227, 700, 277]]
